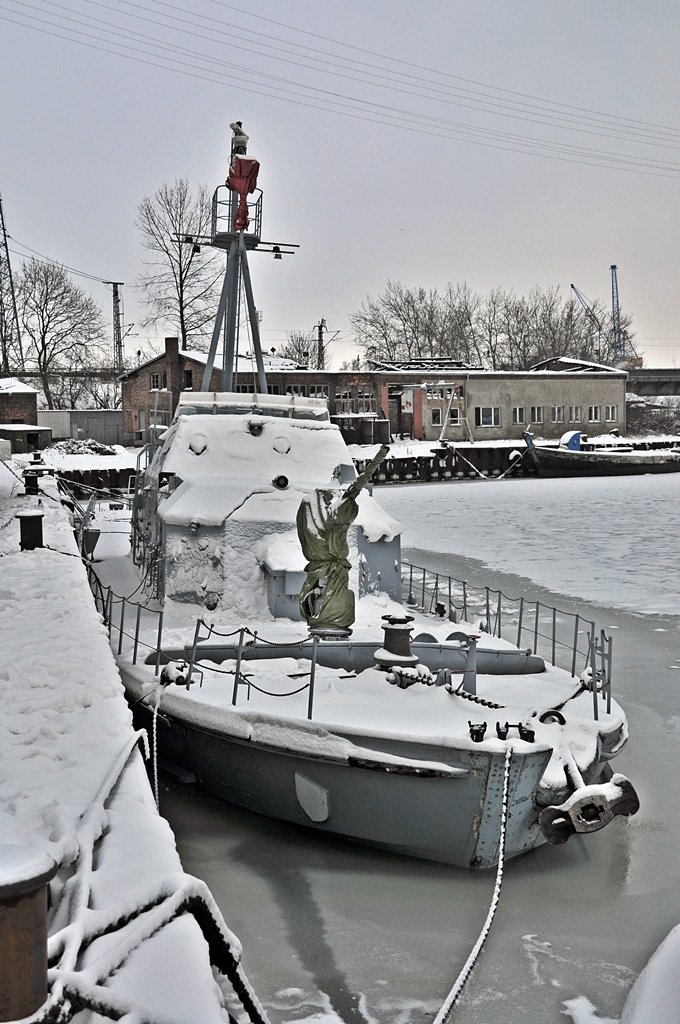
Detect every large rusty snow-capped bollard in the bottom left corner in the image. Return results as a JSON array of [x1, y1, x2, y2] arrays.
[[0, 845, 56, 1021]]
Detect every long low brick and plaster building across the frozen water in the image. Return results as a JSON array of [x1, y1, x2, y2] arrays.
[[116, 338, 627, 443]]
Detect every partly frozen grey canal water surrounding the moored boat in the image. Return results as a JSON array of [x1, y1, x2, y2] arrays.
[[161, 474, 680, 1024]]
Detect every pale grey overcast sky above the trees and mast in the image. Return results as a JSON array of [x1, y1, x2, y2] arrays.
[[0, 0, 680, 368]]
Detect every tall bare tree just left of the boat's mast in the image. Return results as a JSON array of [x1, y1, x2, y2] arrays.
[[135, 178, 224, 348]]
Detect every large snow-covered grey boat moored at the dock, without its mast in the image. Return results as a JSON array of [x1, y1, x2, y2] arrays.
[[87, 392, 638, 867]]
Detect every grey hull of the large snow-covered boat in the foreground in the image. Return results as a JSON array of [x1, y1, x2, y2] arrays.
[[129, 675, 606, 868]]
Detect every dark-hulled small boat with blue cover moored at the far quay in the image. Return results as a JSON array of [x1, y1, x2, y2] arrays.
[[523, 430, 680, 476]]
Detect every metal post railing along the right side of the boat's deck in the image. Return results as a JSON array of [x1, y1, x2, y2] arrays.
[[401, 562, 611, 708]]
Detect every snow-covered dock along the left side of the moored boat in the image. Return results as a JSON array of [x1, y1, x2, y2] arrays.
[[0, 462, 266, 1024]]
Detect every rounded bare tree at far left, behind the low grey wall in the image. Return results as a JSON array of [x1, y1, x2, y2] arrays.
[[17, 259, 107, 409]]
